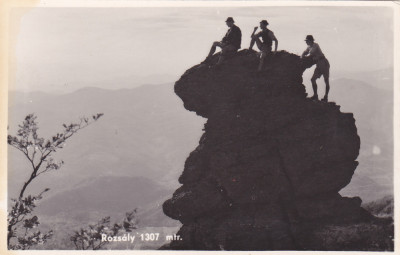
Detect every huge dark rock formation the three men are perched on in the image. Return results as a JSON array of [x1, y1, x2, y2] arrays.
[[163, 50, 390, 250]]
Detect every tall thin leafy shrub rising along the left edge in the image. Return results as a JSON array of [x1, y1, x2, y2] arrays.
[[7, 113, 103, 250]]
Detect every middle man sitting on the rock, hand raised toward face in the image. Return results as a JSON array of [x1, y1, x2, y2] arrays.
[[249, 20, 278, 71]]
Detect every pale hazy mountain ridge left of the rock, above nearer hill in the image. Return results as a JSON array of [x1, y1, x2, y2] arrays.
[[9, 84, 203, 197]]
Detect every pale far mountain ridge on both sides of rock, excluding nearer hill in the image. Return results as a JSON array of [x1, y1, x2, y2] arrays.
[[9, 79, 393, 201]]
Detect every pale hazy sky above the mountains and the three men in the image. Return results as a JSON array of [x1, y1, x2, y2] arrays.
[[11, 7, 393, 91]]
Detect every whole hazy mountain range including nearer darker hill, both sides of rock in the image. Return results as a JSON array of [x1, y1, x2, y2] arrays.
[[8, 70, 393, 249]]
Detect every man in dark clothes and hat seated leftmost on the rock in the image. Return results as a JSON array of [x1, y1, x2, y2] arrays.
[[204, 17, 242, 65]]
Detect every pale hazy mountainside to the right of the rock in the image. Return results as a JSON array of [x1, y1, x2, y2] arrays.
[[328, 78, 394, 201]]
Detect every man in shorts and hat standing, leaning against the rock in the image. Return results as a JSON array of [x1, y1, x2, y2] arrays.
[[301, 35, 330, 102]]
